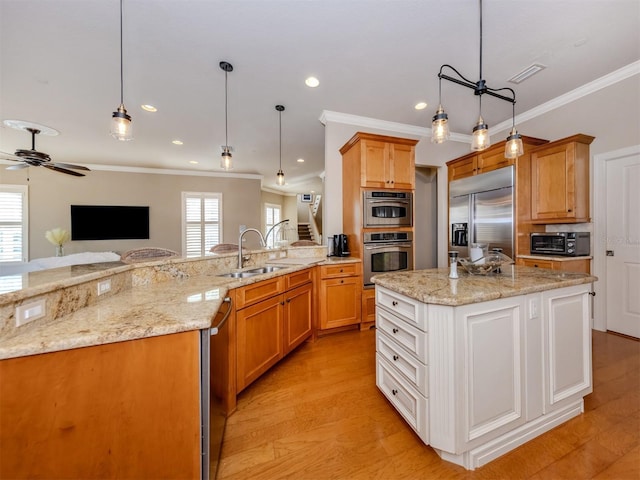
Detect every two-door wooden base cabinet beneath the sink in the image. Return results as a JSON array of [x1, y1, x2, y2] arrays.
[[235, 269, 313, 393]]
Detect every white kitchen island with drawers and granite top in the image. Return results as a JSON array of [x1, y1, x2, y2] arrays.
[[374, 266, 597, 470]]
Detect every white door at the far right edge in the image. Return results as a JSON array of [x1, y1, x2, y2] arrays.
[[599, 152, 640, 337]]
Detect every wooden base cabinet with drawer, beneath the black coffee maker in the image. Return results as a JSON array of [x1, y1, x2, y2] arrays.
[[318, 263, 362, 330]]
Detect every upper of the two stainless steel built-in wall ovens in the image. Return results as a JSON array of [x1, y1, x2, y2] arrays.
[[362, 190, 413, 228]]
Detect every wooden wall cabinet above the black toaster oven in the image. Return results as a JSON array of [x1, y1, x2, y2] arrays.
[[531, 134, 594, 224]]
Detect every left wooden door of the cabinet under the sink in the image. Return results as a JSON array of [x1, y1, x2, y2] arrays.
[[236, 295, 283, 393]]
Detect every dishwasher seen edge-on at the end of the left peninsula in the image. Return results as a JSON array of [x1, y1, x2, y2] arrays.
[[200, 297, 232, 480]]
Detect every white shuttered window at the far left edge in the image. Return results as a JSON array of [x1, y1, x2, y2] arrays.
[[0, 185, 29, 262]]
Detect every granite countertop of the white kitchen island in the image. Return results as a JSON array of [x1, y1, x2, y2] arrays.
[[373, 265, 597, 306]]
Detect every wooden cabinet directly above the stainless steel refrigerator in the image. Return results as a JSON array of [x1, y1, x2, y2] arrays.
[[447, 136, 547, 182]]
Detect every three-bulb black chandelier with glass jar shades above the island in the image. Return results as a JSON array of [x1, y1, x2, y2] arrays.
[[431, 0, 522, 158]]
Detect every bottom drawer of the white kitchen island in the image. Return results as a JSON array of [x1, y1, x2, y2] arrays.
[[376, 354, 429, 445]]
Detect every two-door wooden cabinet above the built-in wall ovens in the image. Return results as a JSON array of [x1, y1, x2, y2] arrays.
[[340, 132, 418, 190]]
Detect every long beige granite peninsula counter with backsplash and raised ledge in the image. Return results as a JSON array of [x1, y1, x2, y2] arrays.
[[0, 248, 360, 359]]
